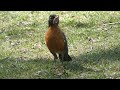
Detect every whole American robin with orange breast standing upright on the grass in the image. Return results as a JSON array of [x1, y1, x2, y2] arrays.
[[45, 14, 72, 62]]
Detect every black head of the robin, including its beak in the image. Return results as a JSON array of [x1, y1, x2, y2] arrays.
[[48, 14, 59, 27]]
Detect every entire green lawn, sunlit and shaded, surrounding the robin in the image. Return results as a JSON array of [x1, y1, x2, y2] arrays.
[[0, 11, 120, 79]]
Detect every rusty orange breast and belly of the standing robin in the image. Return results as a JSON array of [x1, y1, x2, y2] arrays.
[[45, 27, 64, 52]]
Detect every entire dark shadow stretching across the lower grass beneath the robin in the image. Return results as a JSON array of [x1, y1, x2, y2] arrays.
[[0, 46, 120, 79]]
